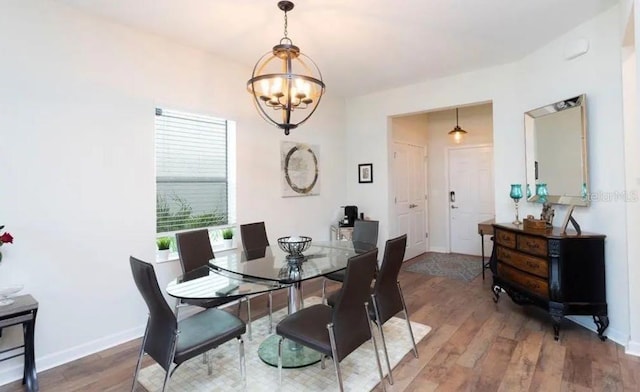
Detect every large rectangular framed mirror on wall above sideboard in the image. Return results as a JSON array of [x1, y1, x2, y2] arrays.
[[524, 94, 589, 207]]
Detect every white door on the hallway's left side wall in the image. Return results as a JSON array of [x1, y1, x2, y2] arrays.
[[393, 143, 428, 260]]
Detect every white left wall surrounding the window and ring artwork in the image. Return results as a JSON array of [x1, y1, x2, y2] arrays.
[[0, 0, 348, 383]]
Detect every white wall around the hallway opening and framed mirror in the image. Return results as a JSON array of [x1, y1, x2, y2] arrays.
[[347, 7, 640, 343]]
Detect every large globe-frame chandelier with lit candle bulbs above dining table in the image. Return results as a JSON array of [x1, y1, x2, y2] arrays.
[[247, 1, 325, 135]]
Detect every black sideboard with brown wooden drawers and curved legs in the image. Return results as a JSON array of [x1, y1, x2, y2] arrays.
[[490, 223, 609, 341]]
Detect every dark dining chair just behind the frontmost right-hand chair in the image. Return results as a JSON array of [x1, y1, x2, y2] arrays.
[[327, 234, 418, 384]]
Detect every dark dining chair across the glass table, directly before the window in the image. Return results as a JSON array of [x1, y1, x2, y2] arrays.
[[176, 229, 251, 339]]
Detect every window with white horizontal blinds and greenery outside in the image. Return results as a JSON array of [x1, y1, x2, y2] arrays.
[[155, 109, 235, 233]]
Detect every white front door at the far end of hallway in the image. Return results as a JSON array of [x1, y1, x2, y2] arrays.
[[449, 146, 494, 255]]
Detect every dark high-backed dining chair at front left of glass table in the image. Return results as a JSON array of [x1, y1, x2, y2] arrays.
[[129, 257, 246, 392]]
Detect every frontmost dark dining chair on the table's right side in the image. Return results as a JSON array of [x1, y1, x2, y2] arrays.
[[276, 249, 386, 391]]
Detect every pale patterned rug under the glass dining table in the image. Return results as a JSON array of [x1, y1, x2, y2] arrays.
[[138, 297, 431, 392]]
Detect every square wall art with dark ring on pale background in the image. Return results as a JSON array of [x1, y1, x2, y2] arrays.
[[280, 141, 320, 197]]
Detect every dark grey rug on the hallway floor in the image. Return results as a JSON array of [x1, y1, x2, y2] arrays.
[[404, 252, 482, 282]]
